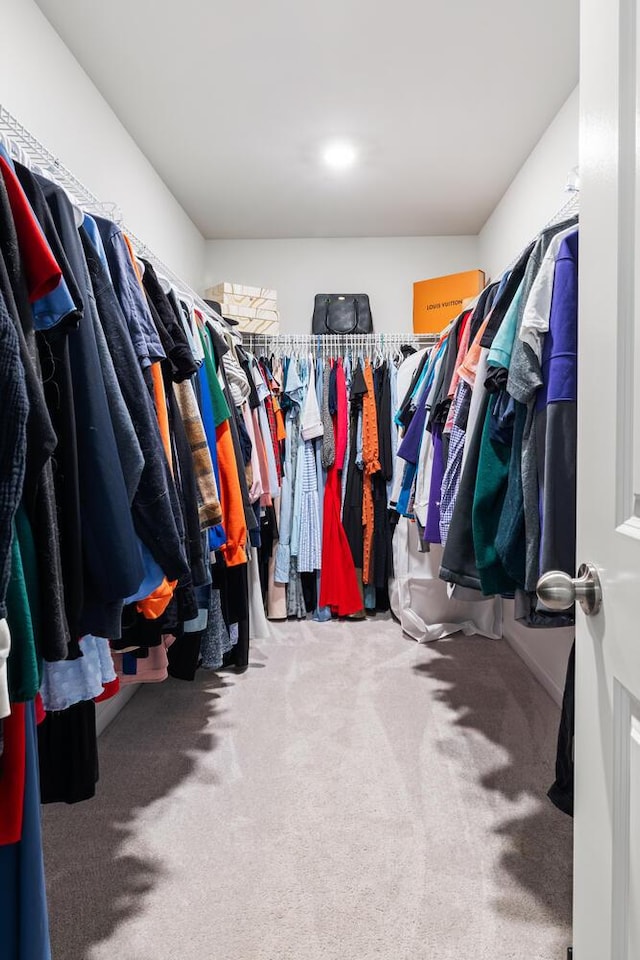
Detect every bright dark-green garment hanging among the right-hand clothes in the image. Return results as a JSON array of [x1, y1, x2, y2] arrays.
[[473, 394, 516, 597]]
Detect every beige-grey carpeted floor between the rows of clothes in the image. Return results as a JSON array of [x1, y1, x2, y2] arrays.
[[44, 621, 571, 960]]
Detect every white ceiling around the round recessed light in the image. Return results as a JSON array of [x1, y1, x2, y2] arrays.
[[38, 0, 579, 238]]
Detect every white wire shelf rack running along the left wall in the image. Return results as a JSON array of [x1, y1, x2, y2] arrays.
[[0, 104, 235, 336]]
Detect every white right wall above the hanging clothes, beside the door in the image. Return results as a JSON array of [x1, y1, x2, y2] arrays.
[[479, 87, 579, 277]]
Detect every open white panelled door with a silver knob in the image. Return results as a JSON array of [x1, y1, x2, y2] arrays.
[[574, 0, 640, 960]]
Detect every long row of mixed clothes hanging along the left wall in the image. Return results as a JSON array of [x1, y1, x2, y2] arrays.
[[0, 135, 282, 823]]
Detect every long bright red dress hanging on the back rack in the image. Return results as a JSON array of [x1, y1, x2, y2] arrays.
[[320, 361, 362, 617]]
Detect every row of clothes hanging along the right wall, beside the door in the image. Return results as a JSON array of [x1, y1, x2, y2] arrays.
[[384, 218, 578, 712]]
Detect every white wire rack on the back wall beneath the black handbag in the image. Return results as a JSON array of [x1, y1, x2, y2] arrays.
[[242, 333, 439, 359]]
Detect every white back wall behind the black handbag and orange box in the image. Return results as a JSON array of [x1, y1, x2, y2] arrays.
[[205, 237, 478, 333]]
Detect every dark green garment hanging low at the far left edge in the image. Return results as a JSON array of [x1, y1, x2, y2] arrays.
[[7, 505, 42, 703]]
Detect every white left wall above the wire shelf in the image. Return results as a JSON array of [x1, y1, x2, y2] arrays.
[[0, 0, 204, 288]]
